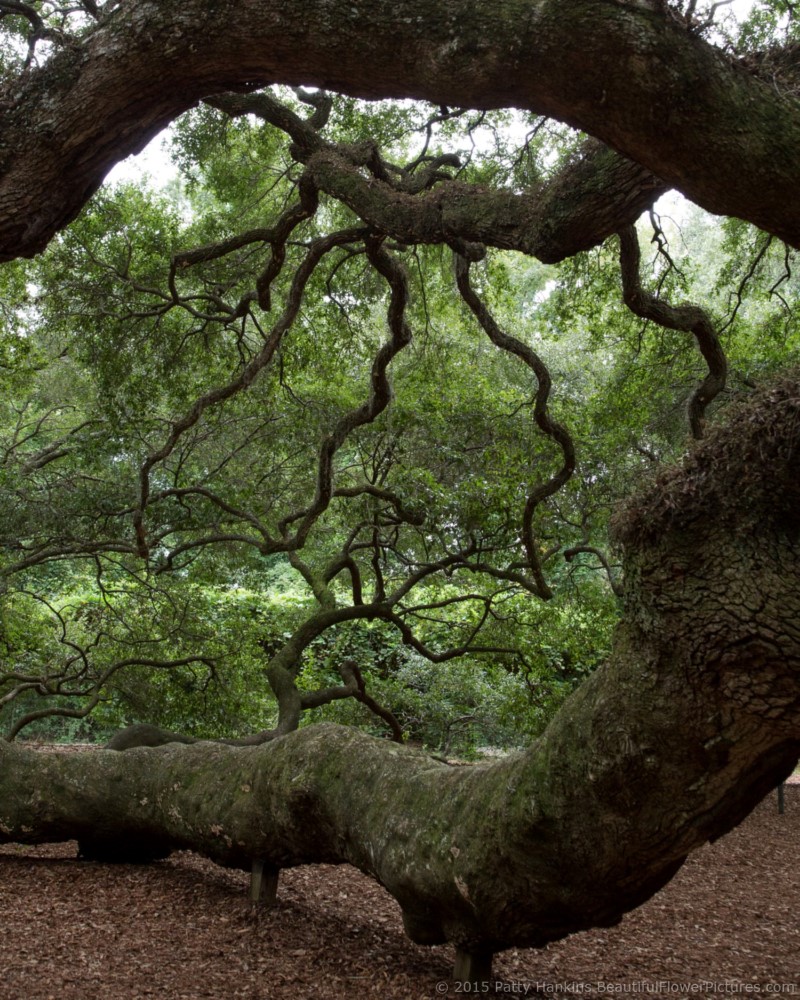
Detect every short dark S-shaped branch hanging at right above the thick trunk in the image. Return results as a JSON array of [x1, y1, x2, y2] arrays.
[[619, 226, 728, 440]]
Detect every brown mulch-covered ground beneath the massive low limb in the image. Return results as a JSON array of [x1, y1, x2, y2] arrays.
[[0, 752, 800, 1000]]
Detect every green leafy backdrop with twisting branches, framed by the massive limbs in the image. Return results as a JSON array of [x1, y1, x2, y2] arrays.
[[2, 0, 796, 748]]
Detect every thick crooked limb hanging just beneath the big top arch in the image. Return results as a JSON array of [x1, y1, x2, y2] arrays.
[[205, 91, 667, 263]]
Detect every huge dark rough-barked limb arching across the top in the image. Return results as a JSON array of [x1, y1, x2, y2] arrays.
[[0, 0, 800, 259]]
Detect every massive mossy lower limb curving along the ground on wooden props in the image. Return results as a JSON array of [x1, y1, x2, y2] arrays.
[[0, 379, 800, 953]]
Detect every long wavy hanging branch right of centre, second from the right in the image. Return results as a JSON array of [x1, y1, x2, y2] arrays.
[[455, 254, 575, 599]]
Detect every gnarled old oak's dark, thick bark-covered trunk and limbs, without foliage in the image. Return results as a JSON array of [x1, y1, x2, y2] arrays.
[[0, 0, 800, 975]]
